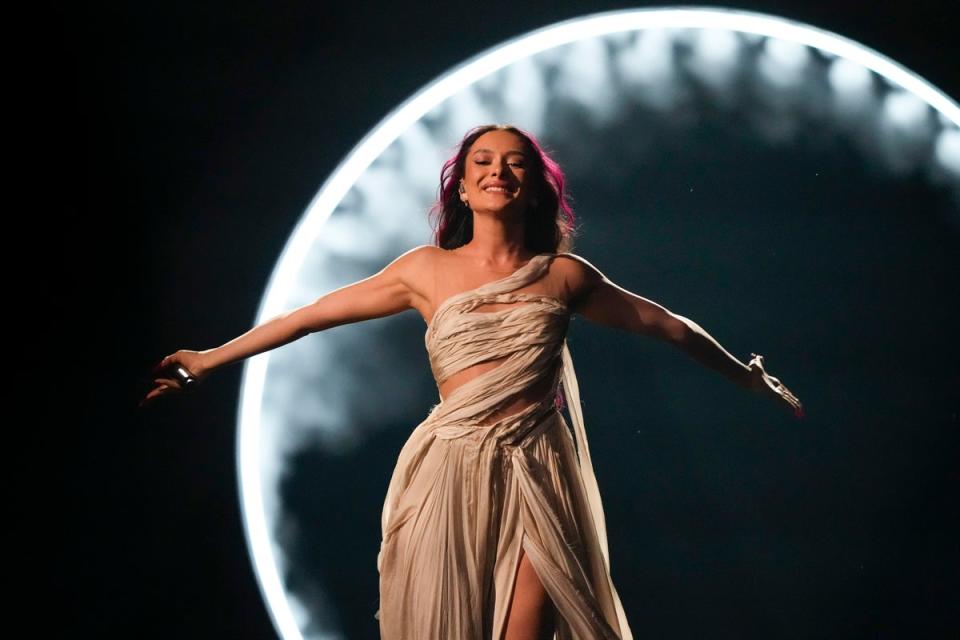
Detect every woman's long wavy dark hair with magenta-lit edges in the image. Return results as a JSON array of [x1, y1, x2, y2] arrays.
[[430, 124, 576, 253]]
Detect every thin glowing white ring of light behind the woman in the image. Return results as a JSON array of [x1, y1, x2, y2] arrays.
[[237, 9, 960, 640]]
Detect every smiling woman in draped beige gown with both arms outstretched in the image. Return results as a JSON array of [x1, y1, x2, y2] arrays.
[[145, 125, 802, 640]]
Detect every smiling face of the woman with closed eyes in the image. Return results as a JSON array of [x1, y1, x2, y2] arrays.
[[460, 129, 532, 215]]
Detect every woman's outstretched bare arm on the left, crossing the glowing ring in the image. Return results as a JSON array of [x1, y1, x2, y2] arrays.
[[144, 245, 436, 400]]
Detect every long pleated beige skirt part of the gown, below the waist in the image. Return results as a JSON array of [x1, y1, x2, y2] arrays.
[[375, 407, 631, 640]]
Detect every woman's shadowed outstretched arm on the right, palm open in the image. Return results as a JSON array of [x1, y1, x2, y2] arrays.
[[561, 253, 803, 418]]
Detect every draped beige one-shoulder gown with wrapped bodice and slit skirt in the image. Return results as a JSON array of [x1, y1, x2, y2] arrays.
[[375, 253, 633, 640]]
